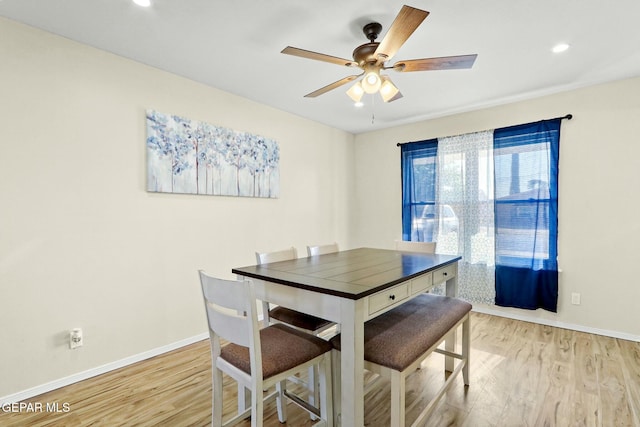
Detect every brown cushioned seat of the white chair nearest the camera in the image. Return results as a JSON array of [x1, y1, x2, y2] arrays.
[[220, 323, 332, 378]]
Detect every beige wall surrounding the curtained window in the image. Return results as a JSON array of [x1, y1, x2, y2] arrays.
[[352, 78, 640, 340]]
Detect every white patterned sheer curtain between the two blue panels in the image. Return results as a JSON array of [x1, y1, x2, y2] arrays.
[[434, 131, 495, 304]]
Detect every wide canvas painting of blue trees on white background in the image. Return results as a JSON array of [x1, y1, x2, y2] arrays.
[[147, 110, 280, 198]]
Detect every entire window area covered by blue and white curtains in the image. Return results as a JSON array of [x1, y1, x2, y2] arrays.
[[402, 119, 561, 312]]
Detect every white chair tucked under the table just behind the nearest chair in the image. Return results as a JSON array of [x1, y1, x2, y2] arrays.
[[256, 246, 334, 418]]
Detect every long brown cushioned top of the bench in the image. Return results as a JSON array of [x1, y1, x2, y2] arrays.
[[331, 294, 472, 371]]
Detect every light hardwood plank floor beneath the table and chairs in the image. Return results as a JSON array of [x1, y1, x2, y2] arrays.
[[0, 313, 640, 427]]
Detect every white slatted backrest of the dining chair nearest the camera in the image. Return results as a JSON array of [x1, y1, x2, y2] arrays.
[[199, 270, 262, 372]]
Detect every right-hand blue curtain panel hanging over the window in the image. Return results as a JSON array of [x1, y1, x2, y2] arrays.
[[494, 119, 560, 312]]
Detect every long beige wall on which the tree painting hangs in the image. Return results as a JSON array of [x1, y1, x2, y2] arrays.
[[0, 18, 353, 397]]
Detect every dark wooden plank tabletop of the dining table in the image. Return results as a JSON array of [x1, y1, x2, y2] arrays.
[[231, 248, 462, 299]]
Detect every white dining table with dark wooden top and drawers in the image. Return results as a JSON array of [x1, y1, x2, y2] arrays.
[[232, 248, 461, 427]]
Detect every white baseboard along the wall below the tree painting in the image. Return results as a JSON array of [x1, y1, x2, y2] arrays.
[[0, 332, 209, 406]]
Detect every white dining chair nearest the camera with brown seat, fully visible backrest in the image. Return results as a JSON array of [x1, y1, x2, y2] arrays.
[[199, 270, 333, 427]]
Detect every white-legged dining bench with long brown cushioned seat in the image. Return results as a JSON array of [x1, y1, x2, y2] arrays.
[[330, 294, 472, 427]]
